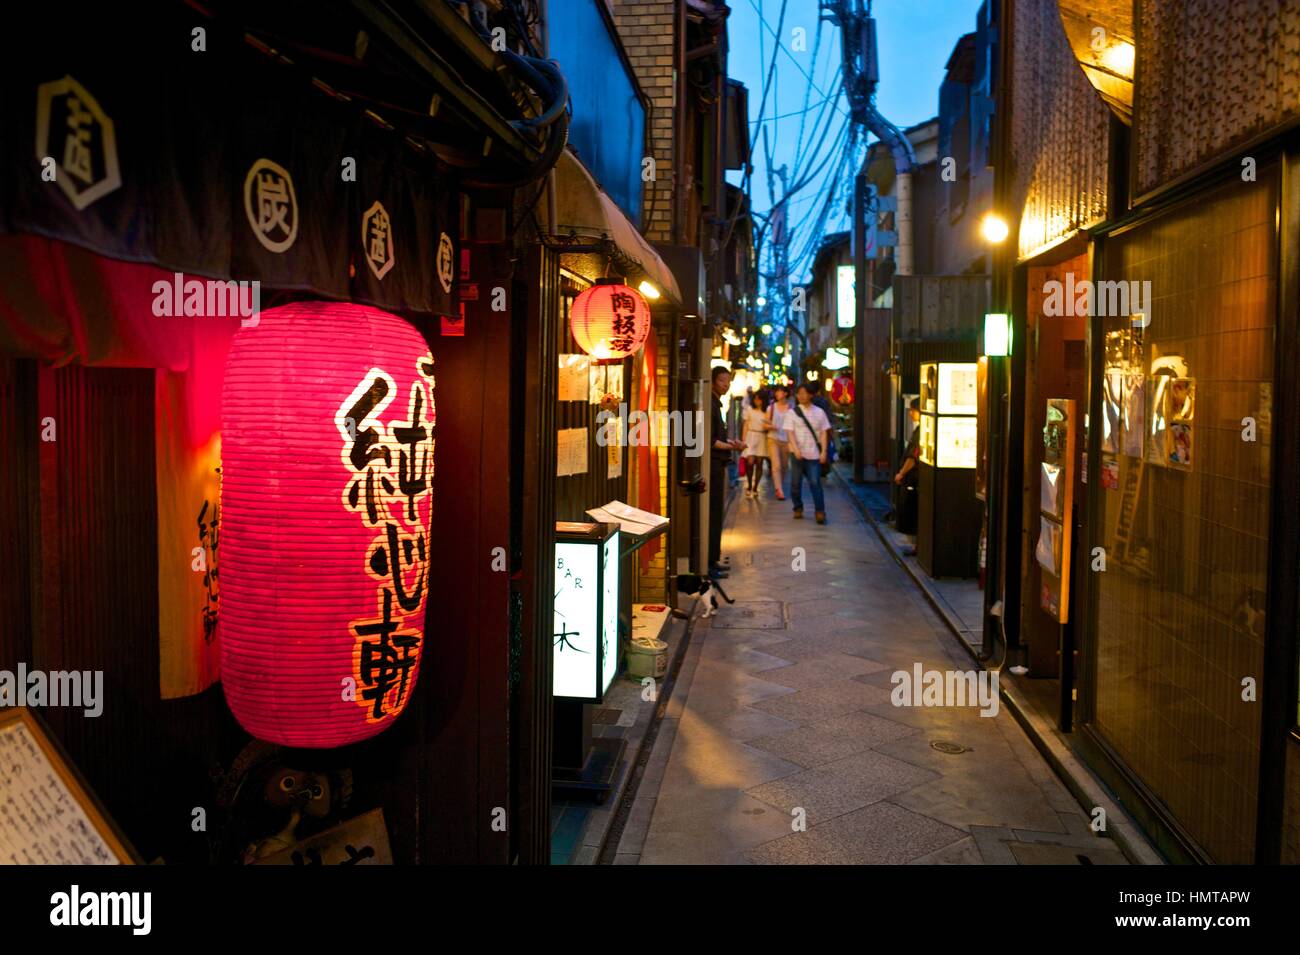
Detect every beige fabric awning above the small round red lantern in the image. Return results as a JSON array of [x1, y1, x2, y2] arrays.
[[555, 149, 681, 307]]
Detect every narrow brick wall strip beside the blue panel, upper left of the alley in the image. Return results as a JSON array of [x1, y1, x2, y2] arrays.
[[614, 0, 677, 242]]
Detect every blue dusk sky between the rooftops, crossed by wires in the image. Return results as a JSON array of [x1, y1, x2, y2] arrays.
[[728, 0, 979, 281]]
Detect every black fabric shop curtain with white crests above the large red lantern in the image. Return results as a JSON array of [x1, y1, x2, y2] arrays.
[[0, 12, 459, 316]]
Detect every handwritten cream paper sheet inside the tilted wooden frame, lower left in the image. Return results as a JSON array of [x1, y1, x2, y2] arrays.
[[0, 720, 121, 865]]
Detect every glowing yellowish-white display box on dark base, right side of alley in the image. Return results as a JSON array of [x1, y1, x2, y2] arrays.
[[917, 361, 982, 577]]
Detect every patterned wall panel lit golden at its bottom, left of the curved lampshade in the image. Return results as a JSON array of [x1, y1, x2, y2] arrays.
[[1009, 0, 1110, 259]]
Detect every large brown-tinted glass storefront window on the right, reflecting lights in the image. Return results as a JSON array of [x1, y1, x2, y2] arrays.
[[1093, 174, 1277, 863]]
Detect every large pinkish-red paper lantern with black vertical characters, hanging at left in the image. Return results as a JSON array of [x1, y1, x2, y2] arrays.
[[220, 301, 436, 747]]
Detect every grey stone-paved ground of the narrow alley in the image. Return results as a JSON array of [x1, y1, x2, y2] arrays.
[[615, 478, 1126, 864]]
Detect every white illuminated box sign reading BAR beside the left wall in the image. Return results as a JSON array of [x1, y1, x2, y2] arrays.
[[553, 521, 619, 703]]
